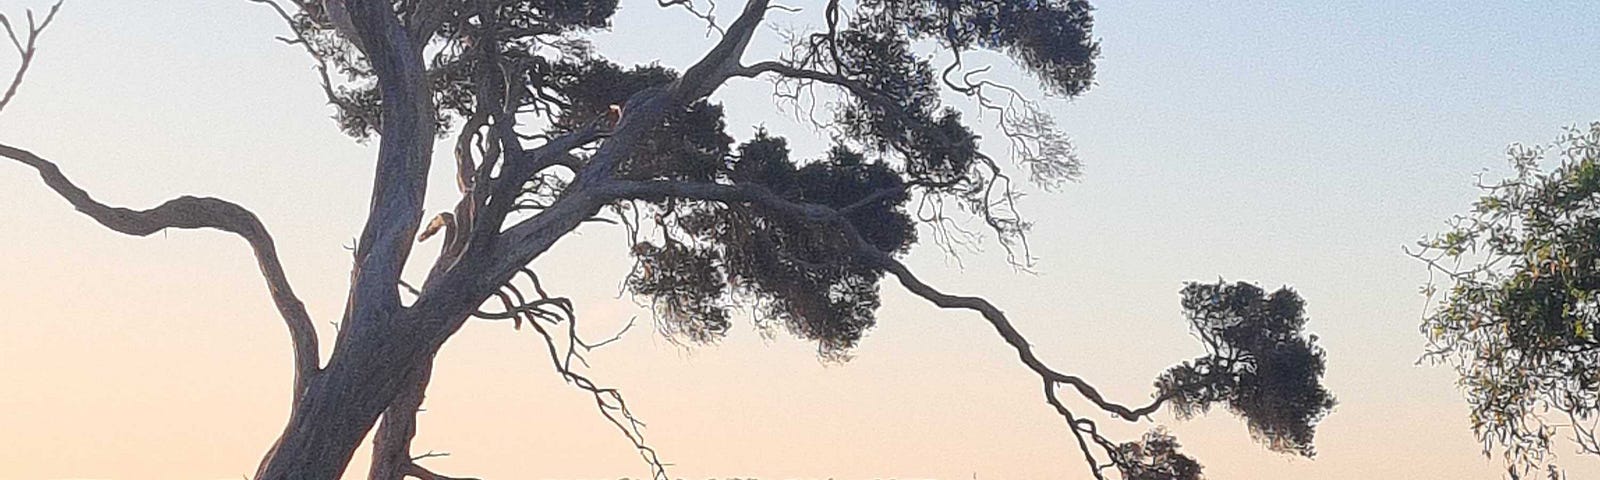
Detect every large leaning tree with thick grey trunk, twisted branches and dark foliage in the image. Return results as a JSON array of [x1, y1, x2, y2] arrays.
[[0, 0, 1333, 480]]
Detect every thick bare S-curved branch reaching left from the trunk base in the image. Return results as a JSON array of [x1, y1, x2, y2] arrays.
[[0, 144, 320, 402]]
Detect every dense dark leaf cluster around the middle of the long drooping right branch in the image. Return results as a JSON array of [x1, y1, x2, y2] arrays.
[[630, 133, 915, 358]]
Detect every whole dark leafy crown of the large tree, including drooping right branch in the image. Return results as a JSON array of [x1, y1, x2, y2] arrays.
[[256, 0, 1334, 478]]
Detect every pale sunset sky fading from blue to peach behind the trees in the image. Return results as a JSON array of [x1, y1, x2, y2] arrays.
[[0, 0, 1600, 480]]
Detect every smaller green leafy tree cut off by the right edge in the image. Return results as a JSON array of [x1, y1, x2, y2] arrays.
[[1408, 122, 1600, 478]]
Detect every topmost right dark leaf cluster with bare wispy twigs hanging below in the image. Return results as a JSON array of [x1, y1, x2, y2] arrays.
[[764, 0, 1099, 262]]
